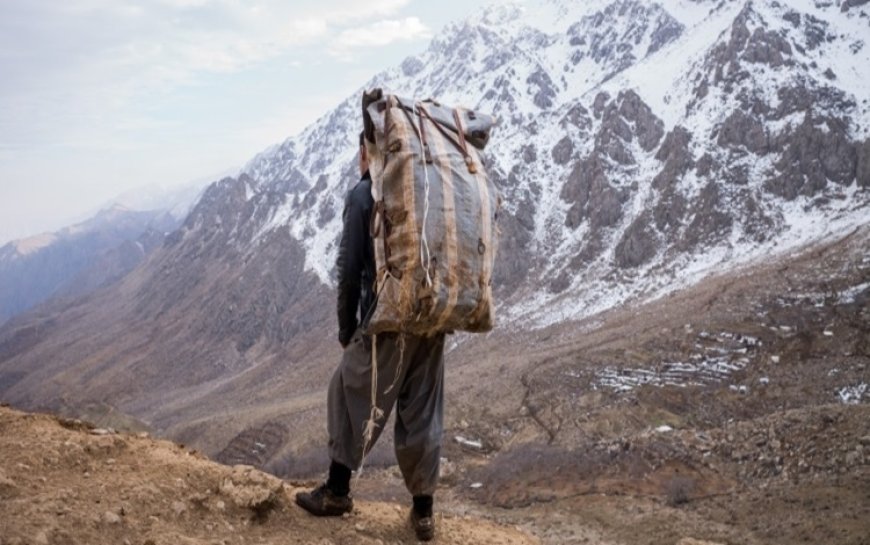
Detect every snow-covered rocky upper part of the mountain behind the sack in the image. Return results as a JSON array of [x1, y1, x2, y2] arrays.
[[238, 0, 870, 324]]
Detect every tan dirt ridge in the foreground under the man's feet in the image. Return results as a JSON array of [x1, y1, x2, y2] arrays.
[[0, 407, 537, 545]]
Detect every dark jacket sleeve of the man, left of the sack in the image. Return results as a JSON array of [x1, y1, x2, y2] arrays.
[[336, 172, 375, 346]]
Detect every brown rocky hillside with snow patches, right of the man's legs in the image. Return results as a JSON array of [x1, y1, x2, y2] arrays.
[[424, 229, 870, 545]]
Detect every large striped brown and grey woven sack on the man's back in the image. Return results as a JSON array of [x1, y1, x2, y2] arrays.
[[363, 89, 500, 335]]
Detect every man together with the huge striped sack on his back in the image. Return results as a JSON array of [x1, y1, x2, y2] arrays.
[[296, 89, 498, 541]]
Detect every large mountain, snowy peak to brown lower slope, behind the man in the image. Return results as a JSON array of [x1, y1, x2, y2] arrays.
[[0, 0, 870, 463]]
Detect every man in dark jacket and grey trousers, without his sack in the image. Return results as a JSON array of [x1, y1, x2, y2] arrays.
[[296, 133, 444, 541]]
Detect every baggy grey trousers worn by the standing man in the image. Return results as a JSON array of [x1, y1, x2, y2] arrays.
[[327, 330, 444, 496]]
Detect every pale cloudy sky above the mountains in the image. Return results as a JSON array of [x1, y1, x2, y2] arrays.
[[0, 0, 491, 245]]
